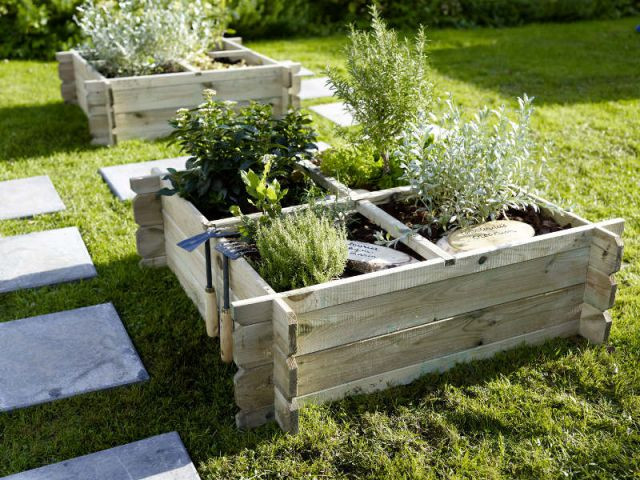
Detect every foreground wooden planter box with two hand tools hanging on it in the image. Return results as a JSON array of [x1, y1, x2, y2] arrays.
[[131, 163, 624, 432]]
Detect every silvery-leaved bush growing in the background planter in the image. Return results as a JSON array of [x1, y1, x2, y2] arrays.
[[74, 0, 229, 77]]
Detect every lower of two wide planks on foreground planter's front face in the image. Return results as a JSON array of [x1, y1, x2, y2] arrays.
[[296, 285, 584, 395]]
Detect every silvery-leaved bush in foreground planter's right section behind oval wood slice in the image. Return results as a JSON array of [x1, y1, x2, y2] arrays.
[[397, 95, 542, 230]]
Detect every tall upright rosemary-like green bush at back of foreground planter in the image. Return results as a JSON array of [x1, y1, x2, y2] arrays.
[[328, 6, 432, 174]]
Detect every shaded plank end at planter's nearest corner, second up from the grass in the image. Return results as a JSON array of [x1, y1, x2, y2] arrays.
[[233, 363, 273, 410]]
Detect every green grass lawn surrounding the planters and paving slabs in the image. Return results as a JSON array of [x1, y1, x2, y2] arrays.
[[0, 18, 640, 480]]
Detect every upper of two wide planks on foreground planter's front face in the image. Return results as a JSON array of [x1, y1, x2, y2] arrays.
[[297, 248, 589, 354]]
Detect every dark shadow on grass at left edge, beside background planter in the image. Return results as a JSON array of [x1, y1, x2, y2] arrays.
[[0, 103, 99, 161]]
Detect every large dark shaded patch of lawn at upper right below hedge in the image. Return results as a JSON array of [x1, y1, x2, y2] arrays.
[[430, 20, 640, 104]]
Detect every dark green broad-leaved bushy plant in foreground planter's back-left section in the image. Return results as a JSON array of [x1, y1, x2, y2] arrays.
[[162, 91, 317, 219]]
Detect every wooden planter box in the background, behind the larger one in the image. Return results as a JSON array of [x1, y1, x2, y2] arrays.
[[56, 38, 300, 145]]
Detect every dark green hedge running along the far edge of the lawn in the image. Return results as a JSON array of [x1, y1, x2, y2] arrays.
[[0, 0, 640, 58]]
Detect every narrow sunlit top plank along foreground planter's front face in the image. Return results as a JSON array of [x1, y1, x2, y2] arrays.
[[282, 225, 594, 315]]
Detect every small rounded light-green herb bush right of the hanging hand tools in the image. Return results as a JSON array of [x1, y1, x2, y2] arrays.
[[256, 209, 349, 292]]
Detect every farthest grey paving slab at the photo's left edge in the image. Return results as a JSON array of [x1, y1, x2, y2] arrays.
[[0, 175, 65, 220]]
